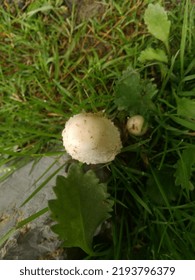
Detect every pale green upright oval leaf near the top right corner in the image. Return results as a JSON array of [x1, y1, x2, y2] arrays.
[[144, 3, 171, 46]]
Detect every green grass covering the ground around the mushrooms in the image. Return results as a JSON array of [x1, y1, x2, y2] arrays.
[[0, 1, 195, 259]]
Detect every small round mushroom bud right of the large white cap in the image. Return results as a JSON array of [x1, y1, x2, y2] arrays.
[[126, 115, 148, 136]]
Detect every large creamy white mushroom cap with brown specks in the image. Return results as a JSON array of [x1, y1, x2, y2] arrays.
[[62, 113, 122, 164]]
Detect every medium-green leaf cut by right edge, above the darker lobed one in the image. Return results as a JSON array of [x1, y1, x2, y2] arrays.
[[176, 97, 195, 119]]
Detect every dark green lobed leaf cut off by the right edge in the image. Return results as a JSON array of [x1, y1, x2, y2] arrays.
[[175, 147, 195, 193]]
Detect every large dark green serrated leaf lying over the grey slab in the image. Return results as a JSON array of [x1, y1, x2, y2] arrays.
[[48, 164, 113, 254]]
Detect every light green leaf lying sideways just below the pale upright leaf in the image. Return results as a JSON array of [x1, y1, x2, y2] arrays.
[[138, 48, 168, 63]]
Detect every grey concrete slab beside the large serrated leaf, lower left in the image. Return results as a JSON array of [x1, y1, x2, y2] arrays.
[[0, 155, 68, 259]]
